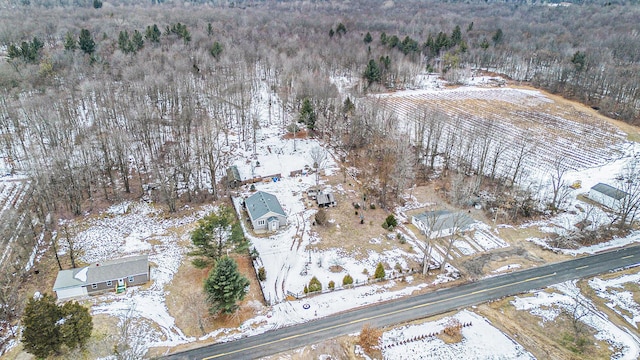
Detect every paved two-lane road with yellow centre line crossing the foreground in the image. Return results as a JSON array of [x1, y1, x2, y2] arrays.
[[168, 246, 640, 360]]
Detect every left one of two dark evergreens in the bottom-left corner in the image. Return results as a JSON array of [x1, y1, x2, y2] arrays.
[[22, 294, 63, 359]]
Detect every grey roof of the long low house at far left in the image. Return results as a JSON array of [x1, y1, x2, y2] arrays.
[[53, 255, 149, 291]]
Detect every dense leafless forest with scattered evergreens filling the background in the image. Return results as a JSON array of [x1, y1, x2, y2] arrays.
[[0, 0, 640, 352]]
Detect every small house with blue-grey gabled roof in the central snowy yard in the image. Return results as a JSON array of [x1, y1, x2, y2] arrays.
[[244, 191, 287, 231]]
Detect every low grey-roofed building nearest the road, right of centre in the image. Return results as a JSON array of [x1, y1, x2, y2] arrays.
[[411, 210, 475, 239]]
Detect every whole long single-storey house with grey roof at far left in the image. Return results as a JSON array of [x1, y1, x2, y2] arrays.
[[53, 255, 150, 300]]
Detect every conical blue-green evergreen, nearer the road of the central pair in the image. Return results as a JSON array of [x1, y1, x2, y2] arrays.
[[204, 256, 249, 314]]
